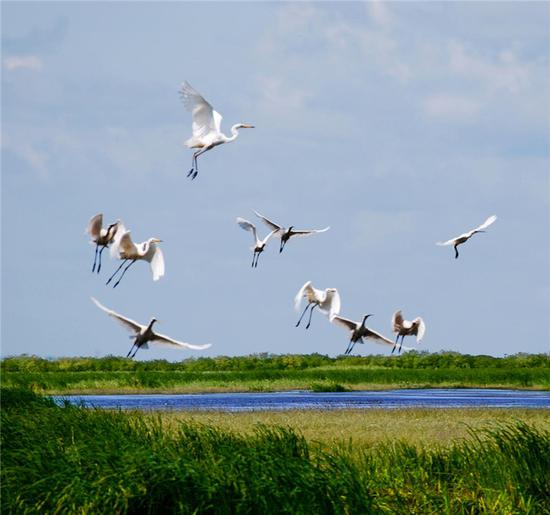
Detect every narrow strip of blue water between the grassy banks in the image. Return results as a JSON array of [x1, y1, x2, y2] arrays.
[[54, 388, 550, 411]]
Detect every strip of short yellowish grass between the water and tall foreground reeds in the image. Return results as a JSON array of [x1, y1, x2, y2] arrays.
[[156, 408, 550, 449]]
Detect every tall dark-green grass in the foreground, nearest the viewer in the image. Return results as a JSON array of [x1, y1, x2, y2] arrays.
[[1, 389, 550, 514]]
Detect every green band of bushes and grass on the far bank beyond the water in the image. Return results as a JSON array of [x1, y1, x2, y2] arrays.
[[1, 352, 550, 393]]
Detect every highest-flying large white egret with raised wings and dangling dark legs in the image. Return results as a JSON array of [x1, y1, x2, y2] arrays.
[[180, 81, 254, 179]]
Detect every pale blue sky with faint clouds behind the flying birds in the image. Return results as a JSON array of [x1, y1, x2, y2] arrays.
[[2, 2, 550, 359]]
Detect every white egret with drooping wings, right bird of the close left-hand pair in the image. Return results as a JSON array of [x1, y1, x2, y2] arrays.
[[105, 226, 164, 288]]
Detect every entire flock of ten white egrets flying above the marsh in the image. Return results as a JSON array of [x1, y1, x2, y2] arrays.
[[87, 82, 497, 357]]
